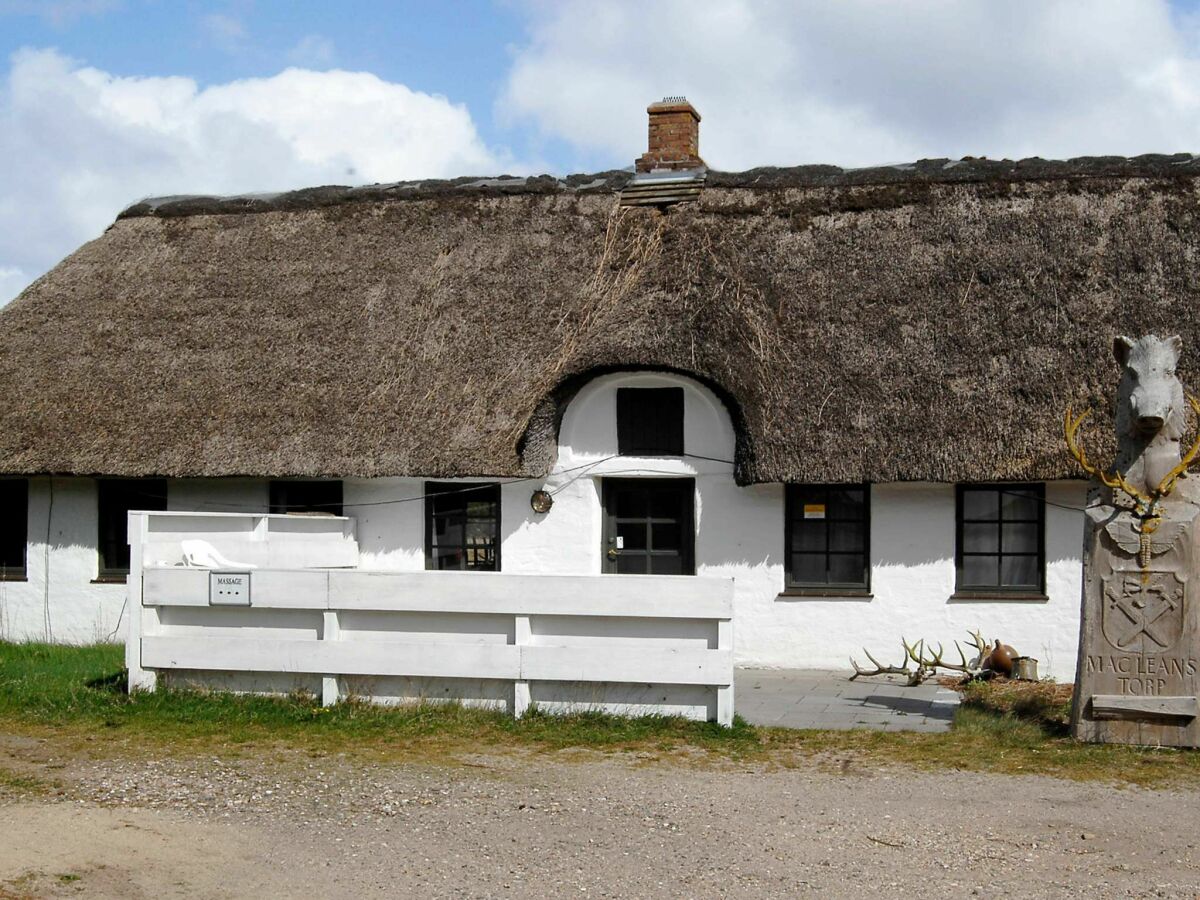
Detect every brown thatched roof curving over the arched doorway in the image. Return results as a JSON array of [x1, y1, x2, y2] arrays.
[[0, 156, 1200, 481]]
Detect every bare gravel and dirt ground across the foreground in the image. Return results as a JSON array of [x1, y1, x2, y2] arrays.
[[0, 737, 1200, 898]]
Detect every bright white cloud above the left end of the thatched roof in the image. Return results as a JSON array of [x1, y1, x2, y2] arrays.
[[0, 50, 514, 304]]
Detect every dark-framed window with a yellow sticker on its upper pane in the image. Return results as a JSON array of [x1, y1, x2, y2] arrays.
[[785, 485, 870, 593]]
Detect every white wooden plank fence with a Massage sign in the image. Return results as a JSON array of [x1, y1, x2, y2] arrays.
[[126, 512, 733, 725]]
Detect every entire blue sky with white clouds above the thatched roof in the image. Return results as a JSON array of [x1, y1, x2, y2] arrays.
[[0, 0, 1200, 305]]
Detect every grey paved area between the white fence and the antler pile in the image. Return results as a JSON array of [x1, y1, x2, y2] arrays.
[[733, 668, 959, 731]]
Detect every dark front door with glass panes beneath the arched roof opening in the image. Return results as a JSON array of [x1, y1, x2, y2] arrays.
[[601, 478, 696, 575]]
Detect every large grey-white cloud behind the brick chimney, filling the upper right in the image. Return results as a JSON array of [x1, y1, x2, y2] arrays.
[[498, 0, 1200, 169]]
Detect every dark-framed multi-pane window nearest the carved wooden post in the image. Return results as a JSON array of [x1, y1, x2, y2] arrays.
[[955, 485, 1045, 594]]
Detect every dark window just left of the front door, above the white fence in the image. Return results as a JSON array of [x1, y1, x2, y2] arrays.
[[425, 481, 500, 572]]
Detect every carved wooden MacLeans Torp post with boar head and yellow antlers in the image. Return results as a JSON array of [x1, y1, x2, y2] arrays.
[[1064, 336, 1200, 746]]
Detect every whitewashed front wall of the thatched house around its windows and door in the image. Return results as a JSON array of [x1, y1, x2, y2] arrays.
[[0, 373, 1086, 679]]
